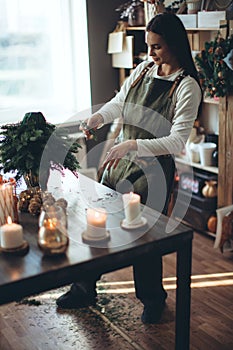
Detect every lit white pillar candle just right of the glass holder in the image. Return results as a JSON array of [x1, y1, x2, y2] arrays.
[[86, 208, 107, 239]]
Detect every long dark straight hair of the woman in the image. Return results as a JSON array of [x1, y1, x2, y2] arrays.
[[146, 13, 200, 85]]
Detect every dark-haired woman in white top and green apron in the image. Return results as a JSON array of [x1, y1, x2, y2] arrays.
[[57, 13, 202, 323]]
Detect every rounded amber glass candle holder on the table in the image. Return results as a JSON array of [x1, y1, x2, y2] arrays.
[[38, 205, 69, 255]]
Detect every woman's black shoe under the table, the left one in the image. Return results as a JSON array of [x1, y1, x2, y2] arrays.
[[56, 283, 97, 309]]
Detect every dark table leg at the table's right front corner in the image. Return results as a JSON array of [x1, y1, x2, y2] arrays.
[[175, 239, 192, 350]]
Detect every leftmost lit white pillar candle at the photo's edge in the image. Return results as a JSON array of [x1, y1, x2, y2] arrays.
[[0, 216, 23, 249]]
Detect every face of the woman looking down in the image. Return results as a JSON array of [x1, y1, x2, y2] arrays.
[[146, 32, 174, 65]]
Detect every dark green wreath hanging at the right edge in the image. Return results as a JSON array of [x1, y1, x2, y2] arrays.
[[195, 33, 233, 97]]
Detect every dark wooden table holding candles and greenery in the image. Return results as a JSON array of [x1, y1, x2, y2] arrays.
[[0, 171, 193, 350]]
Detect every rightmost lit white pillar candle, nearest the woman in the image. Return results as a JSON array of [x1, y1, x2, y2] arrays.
[[122, 192, 141, 225]]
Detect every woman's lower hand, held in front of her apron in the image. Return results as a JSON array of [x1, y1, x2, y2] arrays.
[[102, 140, 137, 170]]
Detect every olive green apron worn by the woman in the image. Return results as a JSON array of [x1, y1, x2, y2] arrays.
[[101, 65, 183, 213]]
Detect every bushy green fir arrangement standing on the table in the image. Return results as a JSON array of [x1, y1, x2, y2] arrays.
[[0, 112, 81, 186]]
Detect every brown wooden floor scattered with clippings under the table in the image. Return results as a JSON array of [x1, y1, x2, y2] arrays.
[[0, 233, 233, 350]]
